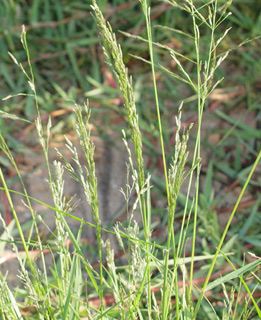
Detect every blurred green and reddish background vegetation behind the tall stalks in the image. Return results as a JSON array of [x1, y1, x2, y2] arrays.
[[0, 0, 261, 254]]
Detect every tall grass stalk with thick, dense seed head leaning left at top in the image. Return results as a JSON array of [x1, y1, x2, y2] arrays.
[[92, 0, 151, 319]]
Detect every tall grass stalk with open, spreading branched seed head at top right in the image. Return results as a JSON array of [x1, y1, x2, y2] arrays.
[[161, 0, 233, 310]]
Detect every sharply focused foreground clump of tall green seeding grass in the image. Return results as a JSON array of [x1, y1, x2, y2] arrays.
[[0, 0, 261, 320]]
